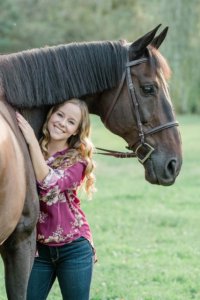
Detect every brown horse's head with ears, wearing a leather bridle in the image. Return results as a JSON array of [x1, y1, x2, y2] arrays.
[[99, 26, 182, 185]]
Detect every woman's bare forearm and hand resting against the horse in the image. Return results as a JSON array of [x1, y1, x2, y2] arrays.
[[16, 112, 49, 181]]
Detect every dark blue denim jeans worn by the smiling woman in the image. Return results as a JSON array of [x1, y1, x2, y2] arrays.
[[27, 237, 93, 300]]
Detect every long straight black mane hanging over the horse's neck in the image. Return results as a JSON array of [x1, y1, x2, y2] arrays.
[[0, 41, 127, 108]]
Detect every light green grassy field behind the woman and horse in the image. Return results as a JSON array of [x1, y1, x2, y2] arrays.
[[0, 116, 200, 300]]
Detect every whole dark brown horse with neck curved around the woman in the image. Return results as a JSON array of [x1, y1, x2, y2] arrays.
[[0, 28, 182, 300]]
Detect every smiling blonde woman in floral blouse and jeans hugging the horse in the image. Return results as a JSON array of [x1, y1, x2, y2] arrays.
[[16, 99, 94, 300]]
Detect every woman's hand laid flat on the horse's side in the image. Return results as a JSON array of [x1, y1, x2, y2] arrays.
[[16, 112, 37, 145]]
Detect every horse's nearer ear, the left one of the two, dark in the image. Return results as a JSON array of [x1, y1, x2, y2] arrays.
[[129, 24, 161, 60]]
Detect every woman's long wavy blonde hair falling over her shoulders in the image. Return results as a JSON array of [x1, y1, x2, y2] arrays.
[[40, 98, 95, 197]]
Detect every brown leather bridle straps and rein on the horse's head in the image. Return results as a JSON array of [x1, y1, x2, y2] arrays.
[[97, 58, 179, 164]]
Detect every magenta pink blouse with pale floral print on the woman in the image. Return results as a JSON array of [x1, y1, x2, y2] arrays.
[[37, 149, 93, 246]]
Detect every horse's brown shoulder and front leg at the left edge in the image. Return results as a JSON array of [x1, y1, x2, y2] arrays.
[[0, 101, 38, 299]]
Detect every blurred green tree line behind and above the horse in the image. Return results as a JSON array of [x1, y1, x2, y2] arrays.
[[0, 0, 200, 113]]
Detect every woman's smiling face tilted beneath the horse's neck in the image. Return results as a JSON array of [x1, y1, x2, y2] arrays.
[[47, 102, 81, 144]]
